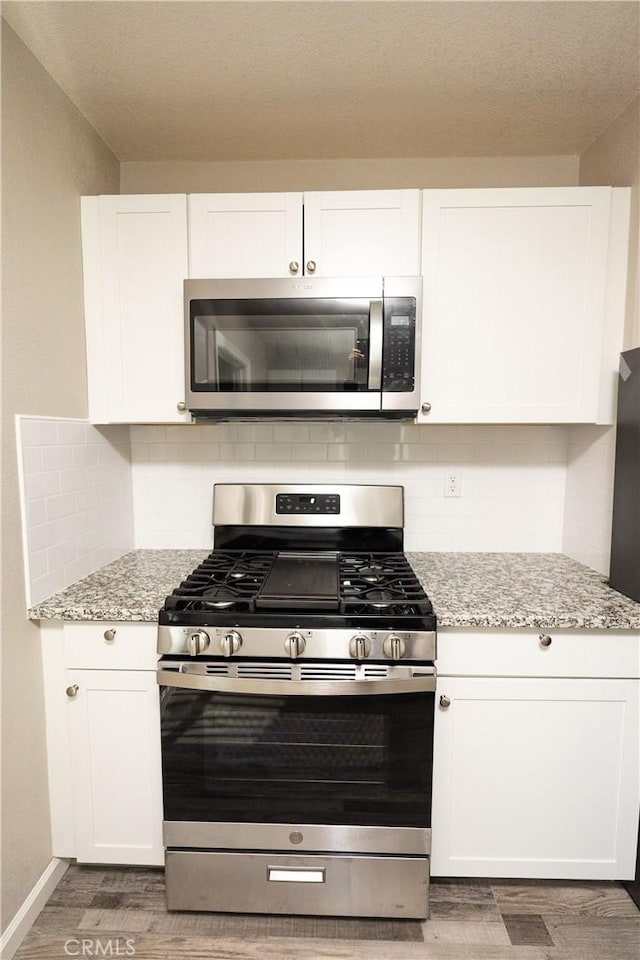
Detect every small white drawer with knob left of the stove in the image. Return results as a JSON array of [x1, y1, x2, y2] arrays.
[[64, 621, 158, 670]]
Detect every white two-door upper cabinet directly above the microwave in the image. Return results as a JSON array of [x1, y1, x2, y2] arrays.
[[189, 190, 420, 278]]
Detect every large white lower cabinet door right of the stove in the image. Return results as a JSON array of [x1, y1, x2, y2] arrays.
[[432, 677, 640, 880]]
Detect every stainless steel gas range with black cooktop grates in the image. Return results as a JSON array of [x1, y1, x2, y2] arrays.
[[158, 484, 436, 917]]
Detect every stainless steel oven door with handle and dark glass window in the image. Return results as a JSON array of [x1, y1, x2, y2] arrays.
[[158, 664, 435, 856]]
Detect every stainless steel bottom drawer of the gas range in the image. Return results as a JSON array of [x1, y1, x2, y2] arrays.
[[165, 850, 429, 919]]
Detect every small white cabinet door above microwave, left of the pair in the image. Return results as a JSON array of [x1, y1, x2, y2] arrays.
[[189, 193, 302, 279]]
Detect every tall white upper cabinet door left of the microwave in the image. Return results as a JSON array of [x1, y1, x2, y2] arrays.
[[82, 194, 191, 423]]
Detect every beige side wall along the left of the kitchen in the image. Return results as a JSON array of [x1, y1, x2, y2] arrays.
[[1, 21, 119, 930]]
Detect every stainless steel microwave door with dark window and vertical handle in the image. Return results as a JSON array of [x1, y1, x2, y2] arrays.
[[185, 279, 383, 414]]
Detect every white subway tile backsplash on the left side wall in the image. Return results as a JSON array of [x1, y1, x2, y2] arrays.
[[17, 417, 134, 606]]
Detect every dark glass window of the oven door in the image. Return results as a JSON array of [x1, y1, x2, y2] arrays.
[[161, 687, 434, 827]]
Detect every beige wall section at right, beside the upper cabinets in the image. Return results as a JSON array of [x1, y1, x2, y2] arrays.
[[579, 97, 640, 350]]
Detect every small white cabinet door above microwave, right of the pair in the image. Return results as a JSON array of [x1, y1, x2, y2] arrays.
[[304, 190, 420, 277]]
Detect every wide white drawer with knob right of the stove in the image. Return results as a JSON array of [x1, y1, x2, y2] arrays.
[[437, 627, 640, 679]]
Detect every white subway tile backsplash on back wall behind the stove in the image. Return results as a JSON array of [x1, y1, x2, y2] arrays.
[[131, 423, 567, 552]]
